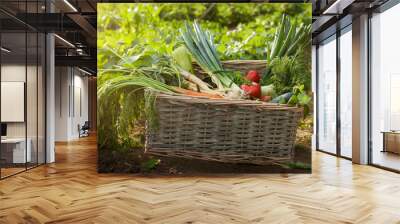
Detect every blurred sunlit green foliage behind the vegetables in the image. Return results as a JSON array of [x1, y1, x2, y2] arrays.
[[97, 3, 311, 68]]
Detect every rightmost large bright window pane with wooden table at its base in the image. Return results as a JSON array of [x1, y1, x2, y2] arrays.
[[371, 5, 400, 170]]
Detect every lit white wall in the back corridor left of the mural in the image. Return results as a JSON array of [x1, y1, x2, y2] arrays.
[[55, 67, 89, 141]]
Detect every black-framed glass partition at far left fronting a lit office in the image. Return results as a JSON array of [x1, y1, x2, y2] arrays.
[[0, 1, 46, 179]]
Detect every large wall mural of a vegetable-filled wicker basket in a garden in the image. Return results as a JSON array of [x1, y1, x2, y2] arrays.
[[97, 3, 313, 175]]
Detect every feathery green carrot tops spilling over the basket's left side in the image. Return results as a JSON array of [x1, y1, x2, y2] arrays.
[[97, 46, 183, 149]]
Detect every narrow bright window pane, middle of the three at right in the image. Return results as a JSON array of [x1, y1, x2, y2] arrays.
[[340, 27, 353, 158]]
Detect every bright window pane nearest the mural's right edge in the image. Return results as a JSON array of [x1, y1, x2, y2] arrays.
[[318, 36, 336, 153]]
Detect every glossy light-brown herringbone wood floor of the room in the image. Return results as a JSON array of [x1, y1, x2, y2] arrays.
[[0, 138, 400, 224]]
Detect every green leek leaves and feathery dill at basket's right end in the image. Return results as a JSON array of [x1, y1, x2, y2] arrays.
[[262, 14, 311, 89]]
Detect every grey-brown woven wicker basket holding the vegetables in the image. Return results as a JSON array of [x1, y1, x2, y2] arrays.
[[145, 61, 302, 164]]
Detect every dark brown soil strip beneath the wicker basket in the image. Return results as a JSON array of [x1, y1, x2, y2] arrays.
[[98, 146, 311, 176]]
